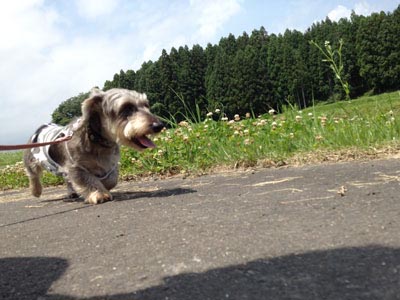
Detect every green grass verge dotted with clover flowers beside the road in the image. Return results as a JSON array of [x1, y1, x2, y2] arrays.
[[0, 92, 400, 189]]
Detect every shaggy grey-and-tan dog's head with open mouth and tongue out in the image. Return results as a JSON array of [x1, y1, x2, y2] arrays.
[[80, 88, 164, 150]]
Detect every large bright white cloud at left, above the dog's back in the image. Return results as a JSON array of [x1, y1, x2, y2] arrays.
[[0, 0, 133, 144]]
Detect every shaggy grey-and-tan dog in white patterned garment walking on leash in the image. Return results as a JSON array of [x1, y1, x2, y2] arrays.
[[24, 88, 164, 204]]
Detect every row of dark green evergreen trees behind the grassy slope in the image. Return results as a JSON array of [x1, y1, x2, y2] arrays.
[[53, 6, 400, 123]]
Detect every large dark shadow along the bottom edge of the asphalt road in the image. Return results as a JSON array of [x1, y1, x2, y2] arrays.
[[0, 246, 400, 300]]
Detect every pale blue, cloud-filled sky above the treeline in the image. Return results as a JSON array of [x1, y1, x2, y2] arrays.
[[0, 0, 400, 144]]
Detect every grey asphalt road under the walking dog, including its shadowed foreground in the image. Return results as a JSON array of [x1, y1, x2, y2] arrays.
[[0, 159, 400, 300]]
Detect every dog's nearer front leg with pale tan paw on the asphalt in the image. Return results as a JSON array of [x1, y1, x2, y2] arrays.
[[69, 167, 112, 204]]
